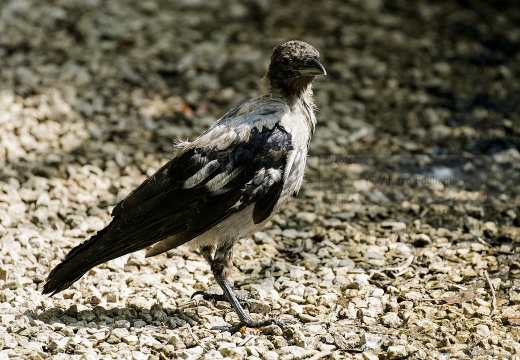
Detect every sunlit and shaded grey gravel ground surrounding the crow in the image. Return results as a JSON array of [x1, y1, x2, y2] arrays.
[[0, 0, 520, 360]]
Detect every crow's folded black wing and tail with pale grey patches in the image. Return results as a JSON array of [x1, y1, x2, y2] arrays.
[[43, 124, 292, 294]]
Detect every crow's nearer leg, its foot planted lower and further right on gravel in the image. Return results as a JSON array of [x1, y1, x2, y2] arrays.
[[202, 240, 283, 334]]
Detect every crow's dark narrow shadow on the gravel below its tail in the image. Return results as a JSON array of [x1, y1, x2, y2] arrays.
[[24, 304, 201, 329]]
